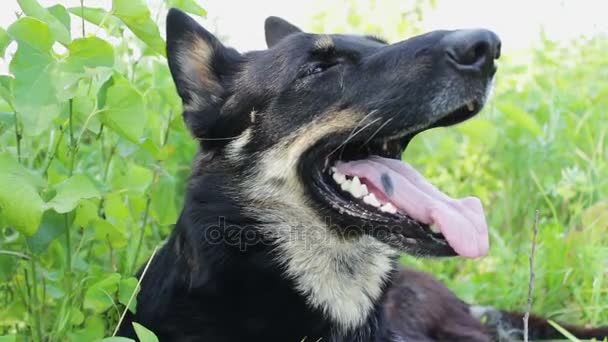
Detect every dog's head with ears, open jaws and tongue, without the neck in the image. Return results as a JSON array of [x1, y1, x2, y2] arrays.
[[167, 10, 500, 257]]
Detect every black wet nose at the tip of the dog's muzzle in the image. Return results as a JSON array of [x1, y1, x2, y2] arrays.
[[441, 29, 500, 77]]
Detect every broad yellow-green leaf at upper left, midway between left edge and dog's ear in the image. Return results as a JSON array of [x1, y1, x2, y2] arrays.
[[65, 37, 114, 72]]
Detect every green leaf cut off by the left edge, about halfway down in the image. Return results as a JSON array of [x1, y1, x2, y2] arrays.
[[0, 156, 44, 235]]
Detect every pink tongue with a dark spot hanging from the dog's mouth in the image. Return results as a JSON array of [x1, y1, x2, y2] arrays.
[[336, 156, 489, 258]]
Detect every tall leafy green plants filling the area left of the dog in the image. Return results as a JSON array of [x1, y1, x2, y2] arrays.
[[0, 0, 205, 341]]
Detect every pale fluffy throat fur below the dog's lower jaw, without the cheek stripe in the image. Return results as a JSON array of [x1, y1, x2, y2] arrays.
[[236, 160, 398, 333]]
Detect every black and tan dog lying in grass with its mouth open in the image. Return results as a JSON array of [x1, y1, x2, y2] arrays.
[[120, 9, 608, 342]]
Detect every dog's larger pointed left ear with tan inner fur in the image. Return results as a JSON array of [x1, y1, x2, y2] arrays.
[[167, 9, 242, 141]]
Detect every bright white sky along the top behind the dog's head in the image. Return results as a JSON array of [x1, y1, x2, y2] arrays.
[[0, 0, 608, 63]]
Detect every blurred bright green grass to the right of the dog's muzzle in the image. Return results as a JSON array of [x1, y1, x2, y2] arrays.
[[404, 39, 608, 324]]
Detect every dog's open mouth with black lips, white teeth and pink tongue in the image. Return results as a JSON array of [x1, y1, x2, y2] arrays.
[[303, 101, 489, 258]]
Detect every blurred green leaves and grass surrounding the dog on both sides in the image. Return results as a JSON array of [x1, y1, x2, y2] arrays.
[[0, 0, 608, 341]]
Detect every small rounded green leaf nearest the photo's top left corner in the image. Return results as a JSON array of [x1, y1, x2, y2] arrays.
[[8, 17, 55, 52]]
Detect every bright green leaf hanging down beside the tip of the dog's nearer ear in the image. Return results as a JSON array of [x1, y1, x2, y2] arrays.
[[112, 0, 165, 56]]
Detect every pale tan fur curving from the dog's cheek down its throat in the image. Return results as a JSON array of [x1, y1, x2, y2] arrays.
[[244, 111, 396, 332]]
